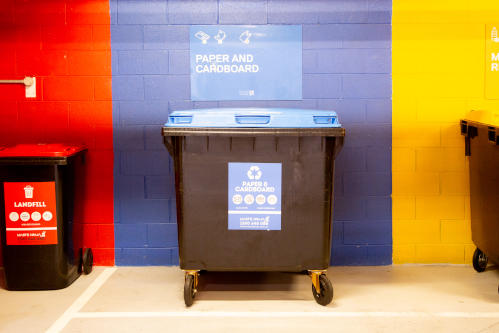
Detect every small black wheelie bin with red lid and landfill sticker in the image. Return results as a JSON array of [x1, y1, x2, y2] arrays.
[[0, 144, 93, 290]]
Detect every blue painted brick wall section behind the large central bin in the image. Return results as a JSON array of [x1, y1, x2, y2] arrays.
[[110, 0, 392, 265]]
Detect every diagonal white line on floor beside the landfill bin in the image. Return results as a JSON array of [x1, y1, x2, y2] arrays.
[[46, 267, 116, 333]]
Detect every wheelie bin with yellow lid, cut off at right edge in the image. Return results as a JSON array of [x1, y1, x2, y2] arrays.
[[461, 111, 499, 272]]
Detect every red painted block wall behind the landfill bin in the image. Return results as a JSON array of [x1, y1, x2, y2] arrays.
[[0, 0, 114, 265]]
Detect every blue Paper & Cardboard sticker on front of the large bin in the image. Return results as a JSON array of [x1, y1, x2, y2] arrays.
[[228, 163, 282, 230]]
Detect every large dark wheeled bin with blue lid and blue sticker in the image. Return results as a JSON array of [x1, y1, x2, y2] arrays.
[[162, 108, 345, 306]]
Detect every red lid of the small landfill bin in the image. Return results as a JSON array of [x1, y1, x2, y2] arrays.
[[0, 143, 87, 158]]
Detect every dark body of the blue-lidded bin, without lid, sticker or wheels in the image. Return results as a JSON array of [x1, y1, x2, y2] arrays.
[[163, 128, 344, 272]]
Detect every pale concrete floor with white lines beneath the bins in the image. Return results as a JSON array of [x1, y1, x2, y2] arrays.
[[0, 265, 499, 333]]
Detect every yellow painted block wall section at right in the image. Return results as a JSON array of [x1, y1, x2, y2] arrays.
[[392, 0, 499, 264]]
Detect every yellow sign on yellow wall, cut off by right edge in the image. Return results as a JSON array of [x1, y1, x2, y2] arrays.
[[485, 23, 499, 99]]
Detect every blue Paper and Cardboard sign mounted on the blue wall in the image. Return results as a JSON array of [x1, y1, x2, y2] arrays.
[[190, 25, 302, 101]]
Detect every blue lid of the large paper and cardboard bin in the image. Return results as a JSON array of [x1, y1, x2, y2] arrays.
[[165, 108, 341, 128]]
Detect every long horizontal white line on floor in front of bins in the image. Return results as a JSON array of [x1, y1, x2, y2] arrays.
[[73, 310, 499, 318]]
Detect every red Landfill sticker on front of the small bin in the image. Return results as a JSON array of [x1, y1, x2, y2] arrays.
[[4, 182, 57, 245]]
